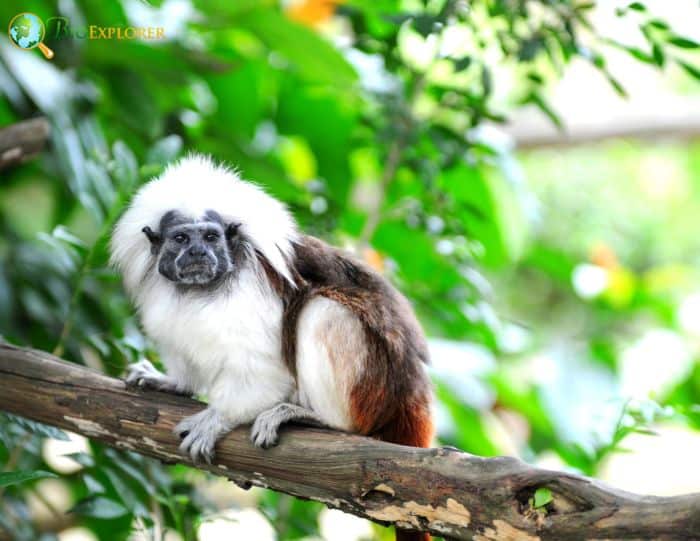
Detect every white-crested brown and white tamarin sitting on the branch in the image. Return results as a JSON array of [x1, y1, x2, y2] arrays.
[[111, 155, 433, 540]]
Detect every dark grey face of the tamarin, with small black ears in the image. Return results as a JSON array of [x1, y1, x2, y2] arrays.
[[143, 211, 238, 286]]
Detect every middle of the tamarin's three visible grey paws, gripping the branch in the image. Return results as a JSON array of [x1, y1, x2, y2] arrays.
[[174, 408, 231, 464]]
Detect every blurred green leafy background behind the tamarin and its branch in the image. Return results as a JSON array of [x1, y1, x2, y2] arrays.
[[0, 0, 700, 541]]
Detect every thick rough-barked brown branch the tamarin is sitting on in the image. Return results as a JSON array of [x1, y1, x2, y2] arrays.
[[0, 344, 700, 541]]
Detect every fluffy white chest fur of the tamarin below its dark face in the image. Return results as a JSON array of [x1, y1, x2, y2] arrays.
[[141, 268, 294, 422]]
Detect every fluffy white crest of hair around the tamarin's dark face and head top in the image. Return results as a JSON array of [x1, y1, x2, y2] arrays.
[[111, 154, 298, 298]]
